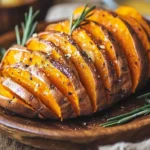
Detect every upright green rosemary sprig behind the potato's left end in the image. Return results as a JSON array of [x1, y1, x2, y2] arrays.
[[15, 7, 39, 45]]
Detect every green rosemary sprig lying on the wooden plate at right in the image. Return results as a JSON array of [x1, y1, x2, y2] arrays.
[[100, 93, 150, 127]]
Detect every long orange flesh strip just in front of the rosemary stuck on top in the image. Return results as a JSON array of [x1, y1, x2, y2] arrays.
[[39, 32, 100, 111]]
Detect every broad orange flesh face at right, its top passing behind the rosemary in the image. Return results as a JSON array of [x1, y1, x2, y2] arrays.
[[74, 7, 142, 92]]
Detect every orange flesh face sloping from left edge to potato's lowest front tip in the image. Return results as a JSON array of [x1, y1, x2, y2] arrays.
[[1, 67, 61, 118]]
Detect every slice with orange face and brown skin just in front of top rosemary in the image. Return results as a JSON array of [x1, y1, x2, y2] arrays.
[[39, 31, 106, 112]]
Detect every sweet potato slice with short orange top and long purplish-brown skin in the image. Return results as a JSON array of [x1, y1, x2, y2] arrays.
[[26, 38, 92, 115]]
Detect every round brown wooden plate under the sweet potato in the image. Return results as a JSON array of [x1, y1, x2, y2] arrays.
[[0, 23, 150, 150]]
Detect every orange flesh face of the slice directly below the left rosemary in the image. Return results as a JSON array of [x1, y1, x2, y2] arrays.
[[2, 48, 80, 114]]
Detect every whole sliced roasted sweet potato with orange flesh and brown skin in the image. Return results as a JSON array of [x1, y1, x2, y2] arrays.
[[0, 7, 150, 120]]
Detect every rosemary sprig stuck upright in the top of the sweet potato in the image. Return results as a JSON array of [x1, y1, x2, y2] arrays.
[[70, 4, 96, 35]]
